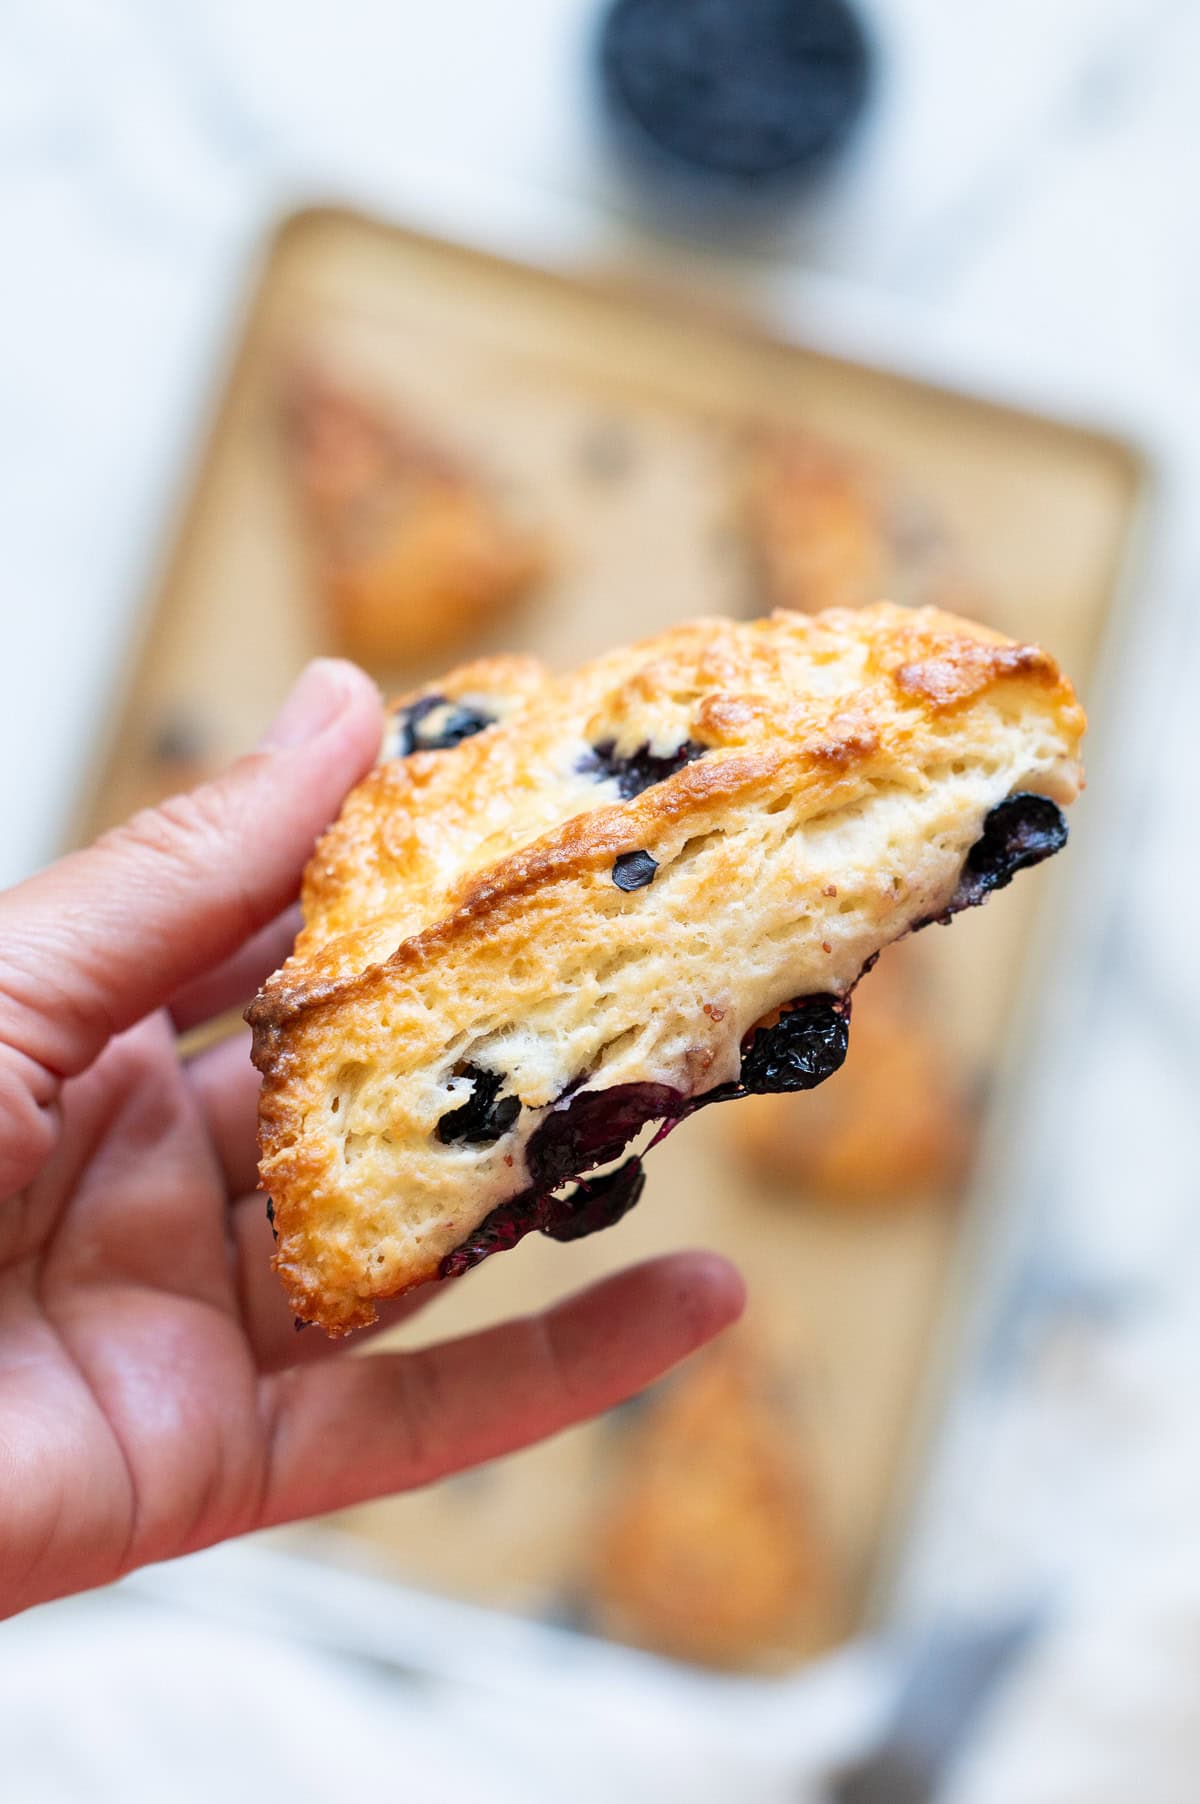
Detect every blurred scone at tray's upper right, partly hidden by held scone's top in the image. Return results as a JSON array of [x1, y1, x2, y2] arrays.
[[738, 428, 980, 613]]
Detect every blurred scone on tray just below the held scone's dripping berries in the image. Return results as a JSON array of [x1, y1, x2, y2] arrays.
[[727, 947, 974, 1207]]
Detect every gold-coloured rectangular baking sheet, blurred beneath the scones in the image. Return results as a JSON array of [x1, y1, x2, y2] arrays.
[[81, 209, 1142, 1658]]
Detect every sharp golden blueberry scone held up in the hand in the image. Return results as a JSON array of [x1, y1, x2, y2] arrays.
[[249, 603, 1085, 1333]]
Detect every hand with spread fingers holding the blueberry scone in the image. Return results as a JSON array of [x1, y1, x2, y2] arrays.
[[0, 662, 742, 1616]]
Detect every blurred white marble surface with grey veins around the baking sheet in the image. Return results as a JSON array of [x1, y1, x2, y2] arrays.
[[0, 0, 1200, 1804]]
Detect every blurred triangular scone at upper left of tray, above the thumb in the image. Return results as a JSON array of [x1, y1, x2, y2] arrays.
[[285, 366, 545, 666]]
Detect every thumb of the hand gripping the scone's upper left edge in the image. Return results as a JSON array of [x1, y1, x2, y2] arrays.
[[0, 658, 381, 1183]]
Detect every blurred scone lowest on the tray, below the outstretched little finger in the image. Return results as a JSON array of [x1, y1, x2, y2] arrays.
[[585, 1335, 841, 1667]]
